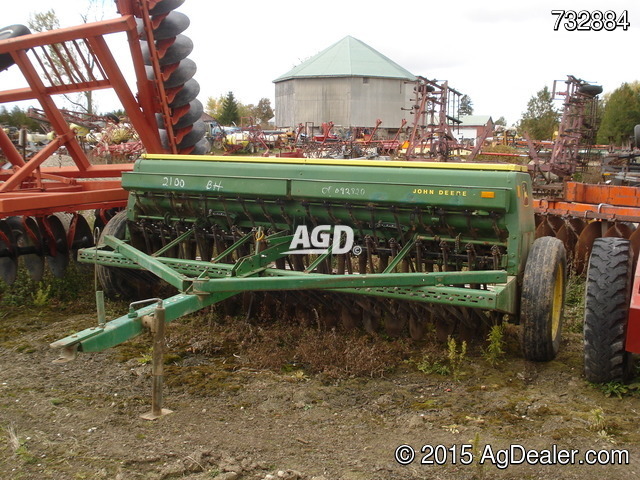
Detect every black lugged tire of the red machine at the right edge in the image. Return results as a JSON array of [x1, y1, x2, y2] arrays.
[[583, 237, 633, 383]]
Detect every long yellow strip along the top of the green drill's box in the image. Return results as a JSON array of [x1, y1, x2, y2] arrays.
[[143, 154, 527, 172]]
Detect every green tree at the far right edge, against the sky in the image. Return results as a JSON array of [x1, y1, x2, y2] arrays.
[[597, 82, 640, 145]]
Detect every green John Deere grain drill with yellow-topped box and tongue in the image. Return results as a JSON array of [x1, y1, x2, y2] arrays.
[[53, 155, 566, 361]]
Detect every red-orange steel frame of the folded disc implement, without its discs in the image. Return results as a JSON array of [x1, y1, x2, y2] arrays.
[[0, 6, 175, 218]]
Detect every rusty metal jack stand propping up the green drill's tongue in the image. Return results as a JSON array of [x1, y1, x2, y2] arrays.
[[138, 299, 173, 420]]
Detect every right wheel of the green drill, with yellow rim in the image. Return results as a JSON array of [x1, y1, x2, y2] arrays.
[[520, 237, 567, 362]]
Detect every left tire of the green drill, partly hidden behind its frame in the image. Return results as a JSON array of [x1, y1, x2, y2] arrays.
[[96, 210, 160, 300]]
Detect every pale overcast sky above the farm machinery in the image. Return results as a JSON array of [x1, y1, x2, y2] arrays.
[[0, 0, 640, 126]]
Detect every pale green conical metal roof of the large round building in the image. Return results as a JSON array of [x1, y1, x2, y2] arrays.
[[273, 36, 416, 83]]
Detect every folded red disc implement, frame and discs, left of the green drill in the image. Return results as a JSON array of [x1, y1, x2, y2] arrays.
[[0, 0, 206, 283]]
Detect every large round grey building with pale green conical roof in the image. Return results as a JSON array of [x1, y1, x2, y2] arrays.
[[274, 36, 416, 129]]
